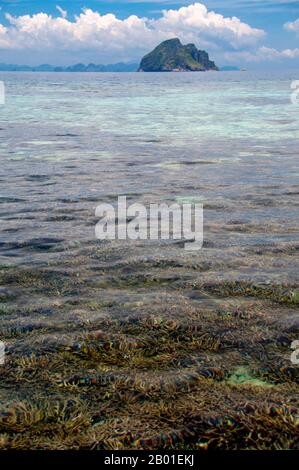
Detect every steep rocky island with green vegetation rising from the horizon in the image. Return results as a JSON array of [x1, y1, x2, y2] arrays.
[[138, 38, 219, 72]]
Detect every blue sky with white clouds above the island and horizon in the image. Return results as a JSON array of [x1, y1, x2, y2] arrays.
[[0, 0, 299, 69]]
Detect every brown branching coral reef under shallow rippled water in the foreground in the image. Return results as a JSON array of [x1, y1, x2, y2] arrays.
[[0, 252, 299, 450]]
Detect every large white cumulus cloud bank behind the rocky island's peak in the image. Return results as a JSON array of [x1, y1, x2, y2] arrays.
[[0, 3, 265, 58]]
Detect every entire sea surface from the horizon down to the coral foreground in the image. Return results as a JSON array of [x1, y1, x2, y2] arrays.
[[0, 70, 299, 449]]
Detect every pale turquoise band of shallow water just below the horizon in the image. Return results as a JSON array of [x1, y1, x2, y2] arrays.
[[0, 71, 299, 146]]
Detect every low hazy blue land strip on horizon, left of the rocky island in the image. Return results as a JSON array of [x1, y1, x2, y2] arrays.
[[0, 62, 138, 72]]
